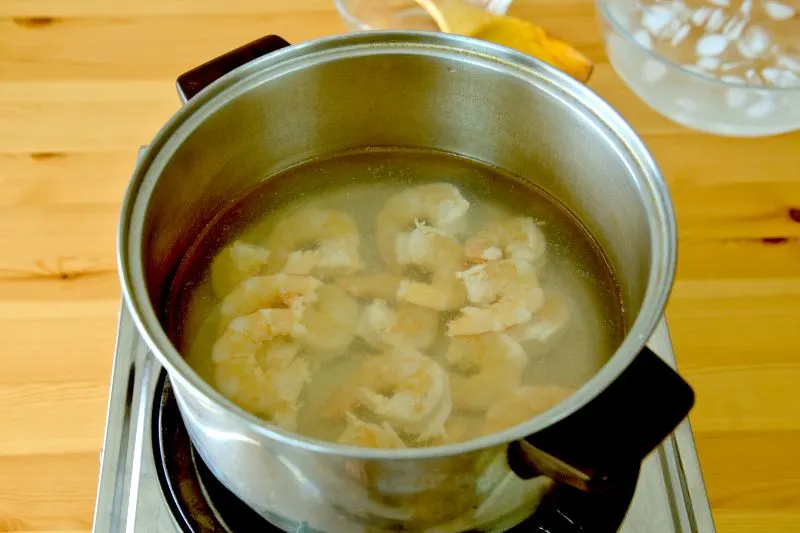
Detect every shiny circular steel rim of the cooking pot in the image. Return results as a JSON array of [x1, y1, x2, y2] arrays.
[[117, 31, 677, 460]]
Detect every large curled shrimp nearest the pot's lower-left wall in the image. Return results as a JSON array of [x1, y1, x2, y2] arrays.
[[211, 309, 309, 429]]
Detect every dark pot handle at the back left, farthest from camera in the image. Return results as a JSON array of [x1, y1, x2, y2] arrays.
[[176, 35, 289, 102]]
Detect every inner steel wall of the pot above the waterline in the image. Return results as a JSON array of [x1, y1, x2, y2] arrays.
[[143, 44, 655, 326]]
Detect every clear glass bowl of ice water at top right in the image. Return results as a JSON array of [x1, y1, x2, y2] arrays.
[[597, 0, 800, 137]]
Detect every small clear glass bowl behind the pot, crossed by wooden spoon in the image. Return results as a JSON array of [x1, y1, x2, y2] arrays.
[[334, 0, 511, 31]]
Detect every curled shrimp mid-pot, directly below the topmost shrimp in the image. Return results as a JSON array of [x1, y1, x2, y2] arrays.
[[395, 223, 466, 311]]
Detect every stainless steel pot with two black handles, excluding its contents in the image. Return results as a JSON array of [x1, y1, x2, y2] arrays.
[[119, 32, 693, 533]]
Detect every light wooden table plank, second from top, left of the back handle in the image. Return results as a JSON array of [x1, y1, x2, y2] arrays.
[[0, 11, 344, 82]]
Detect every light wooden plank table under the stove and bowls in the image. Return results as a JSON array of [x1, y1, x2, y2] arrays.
[[0, 0, 800, 533]]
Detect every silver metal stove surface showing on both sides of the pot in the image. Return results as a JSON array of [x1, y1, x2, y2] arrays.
[[93, 304, 714, 533]]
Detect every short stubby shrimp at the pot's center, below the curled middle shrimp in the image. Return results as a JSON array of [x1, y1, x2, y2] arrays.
[[357, 300, 439, 350]]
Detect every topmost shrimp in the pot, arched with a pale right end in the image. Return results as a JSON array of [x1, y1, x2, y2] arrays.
[[375, 183, 469, 274]]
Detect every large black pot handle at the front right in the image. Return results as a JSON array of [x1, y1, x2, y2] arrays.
[[508, 347, 694, 491]]
